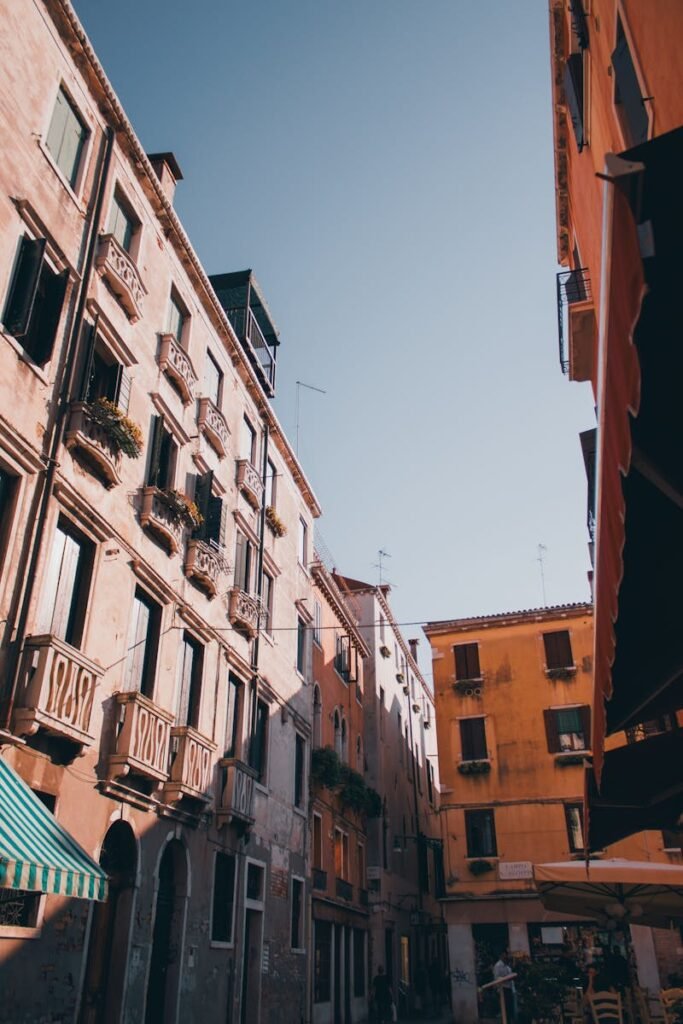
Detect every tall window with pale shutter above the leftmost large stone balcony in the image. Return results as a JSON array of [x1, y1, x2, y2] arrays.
[[39, 516, 94, 647]]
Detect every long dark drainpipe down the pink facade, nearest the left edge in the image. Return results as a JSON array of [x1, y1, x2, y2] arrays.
[[0, 128, 116, 731]]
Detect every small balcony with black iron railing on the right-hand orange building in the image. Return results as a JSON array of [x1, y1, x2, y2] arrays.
[[557, 267, 597, 381]]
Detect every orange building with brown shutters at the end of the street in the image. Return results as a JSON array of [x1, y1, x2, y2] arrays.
[[425, 604, 676, 1024]]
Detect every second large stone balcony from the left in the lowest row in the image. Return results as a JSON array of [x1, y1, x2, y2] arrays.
[[108, 690, 174, 782]]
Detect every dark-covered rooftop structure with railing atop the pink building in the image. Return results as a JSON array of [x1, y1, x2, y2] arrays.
[[209, 270, 280, 398]]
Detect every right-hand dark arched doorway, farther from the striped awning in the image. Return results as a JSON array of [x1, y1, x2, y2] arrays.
[[144, 840, 187, 1024]]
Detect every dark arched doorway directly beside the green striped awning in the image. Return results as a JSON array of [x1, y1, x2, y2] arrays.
[[79, 820, 137, 1024]]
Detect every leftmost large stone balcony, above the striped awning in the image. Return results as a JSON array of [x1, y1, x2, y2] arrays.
[[14, 635, 103, 748]]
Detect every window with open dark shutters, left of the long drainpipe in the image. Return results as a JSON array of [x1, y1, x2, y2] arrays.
[[2, 234, 69, 367]]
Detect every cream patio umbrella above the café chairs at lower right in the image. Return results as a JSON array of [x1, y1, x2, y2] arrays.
[[533, 857, 683, 928]]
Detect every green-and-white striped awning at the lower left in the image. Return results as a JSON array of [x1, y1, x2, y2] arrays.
[[0, 758, 106, 901]]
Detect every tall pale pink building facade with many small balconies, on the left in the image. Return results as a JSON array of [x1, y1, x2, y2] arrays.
[[0, 0, 319, 1024]]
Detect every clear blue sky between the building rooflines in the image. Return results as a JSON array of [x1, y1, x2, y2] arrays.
[[76, 0, 594, 671]]
